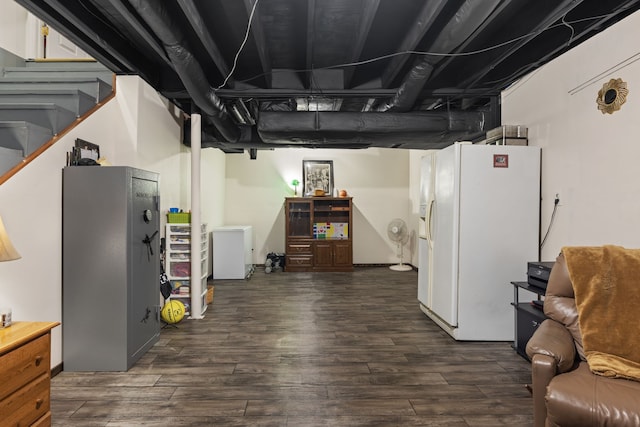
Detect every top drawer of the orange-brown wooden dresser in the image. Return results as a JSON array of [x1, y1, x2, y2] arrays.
[[0, 334, 51, 399]]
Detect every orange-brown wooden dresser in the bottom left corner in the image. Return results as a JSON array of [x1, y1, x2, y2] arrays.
[[0, 322, 60, 427]]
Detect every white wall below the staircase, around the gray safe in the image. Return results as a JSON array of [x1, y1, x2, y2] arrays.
[[0, 76, 216, 366]]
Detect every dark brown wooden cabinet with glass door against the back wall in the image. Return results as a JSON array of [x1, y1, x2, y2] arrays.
[[285, 197, 353, 271]]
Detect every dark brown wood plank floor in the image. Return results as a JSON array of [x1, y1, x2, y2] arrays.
[[51, 267, 532, 427]]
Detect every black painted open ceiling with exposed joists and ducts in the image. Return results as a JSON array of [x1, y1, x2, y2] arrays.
[[17, 0, 640, 154]]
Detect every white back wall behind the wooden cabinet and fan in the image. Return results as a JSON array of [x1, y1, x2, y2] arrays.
[[225, 148, 417, 264]]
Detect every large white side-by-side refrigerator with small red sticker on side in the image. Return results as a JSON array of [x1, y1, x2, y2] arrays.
[[418, 143, 540, 341]]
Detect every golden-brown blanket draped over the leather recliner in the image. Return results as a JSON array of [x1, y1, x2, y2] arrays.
[[562, 245, 640, 381]]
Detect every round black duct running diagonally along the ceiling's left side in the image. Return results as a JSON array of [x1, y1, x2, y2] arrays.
[[129, 0, 240, 142]]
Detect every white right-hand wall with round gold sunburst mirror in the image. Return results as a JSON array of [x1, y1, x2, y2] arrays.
[[502, 12, 640, 260]]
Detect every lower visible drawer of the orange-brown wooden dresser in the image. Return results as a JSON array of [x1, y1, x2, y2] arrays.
[[0, 372, 50, 426]]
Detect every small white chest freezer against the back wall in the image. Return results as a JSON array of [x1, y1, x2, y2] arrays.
[[211, 225, 253, 280]]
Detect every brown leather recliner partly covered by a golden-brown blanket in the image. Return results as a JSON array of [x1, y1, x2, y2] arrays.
[[526, 254, 640, 427]]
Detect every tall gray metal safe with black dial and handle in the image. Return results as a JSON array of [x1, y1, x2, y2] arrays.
[[62, 166, 160, 371]]
